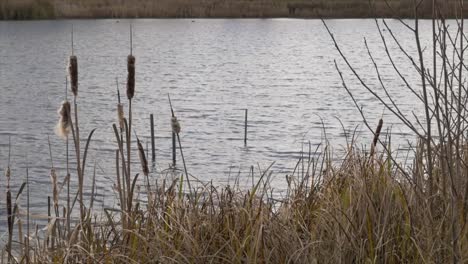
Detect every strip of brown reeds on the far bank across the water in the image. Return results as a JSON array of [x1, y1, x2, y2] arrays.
[[0, 0, 468, 20]]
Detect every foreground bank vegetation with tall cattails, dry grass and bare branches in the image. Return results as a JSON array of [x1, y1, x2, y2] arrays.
[[4, 2, 468, 263]]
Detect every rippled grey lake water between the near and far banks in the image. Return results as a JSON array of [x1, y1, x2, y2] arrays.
[[0, 19, 430, 235]]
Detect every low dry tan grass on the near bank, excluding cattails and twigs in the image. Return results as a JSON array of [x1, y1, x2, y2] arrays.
[[3, 137, 468, 263]]
